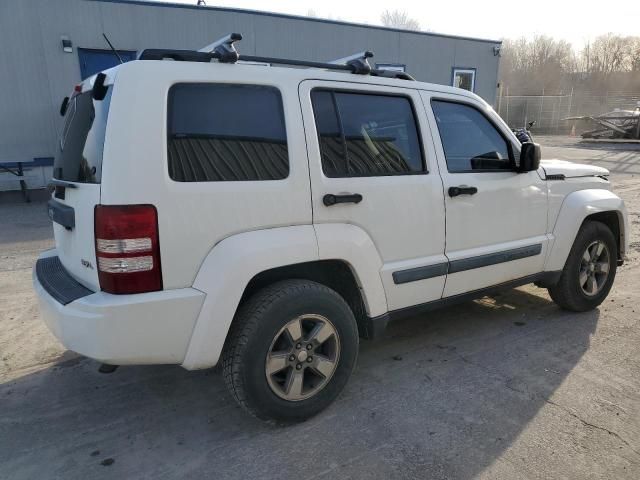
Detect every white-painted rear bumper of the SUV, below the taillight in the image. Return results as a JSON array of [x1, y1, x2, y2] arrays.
[[33, 250, 205, 365]]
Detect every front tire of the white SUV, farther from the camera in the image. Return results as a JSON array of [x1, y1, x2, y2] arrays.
[[548, 221, 618, 312]]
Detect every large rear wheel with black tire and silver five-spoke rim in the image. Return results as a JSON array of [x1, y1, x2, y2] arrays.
[[222, 280, 359, 424]]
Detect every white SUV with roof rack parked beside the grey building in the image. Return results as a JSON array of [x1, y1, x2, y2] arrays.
[[34, 37, 628, 422]]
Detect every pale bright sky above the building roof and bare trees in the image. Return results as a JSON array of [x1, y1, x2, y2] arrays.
[[156, 0, 640, 49]]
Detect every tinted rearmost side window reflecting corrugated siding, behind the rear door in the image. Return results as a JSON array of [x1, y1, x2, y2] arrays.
[[167, 83, 289, 182]]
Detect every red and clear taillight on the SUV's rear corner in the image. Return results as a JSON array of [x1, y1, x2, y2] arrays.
[[95, 205, 162, 293]]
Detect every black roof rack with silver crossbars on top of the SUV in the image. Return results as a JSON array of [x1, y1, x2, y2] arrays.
[[138, 33, 415, 80]]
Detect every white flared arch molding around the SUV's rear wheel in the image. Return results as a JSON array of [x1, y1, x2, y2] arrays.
[[182, 225, 387, 370]]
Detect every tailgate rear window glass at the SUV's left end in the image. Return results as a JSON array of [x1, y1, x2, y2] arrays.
[[53, 88, 112, 183]]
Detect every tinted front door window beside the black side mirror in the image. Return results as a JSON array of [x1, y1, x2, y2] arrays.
[[431, 100, 513, 172]]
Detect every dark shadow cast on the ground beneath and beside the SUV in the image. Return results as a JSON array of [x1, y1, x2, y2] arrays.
[[0, 287, 599, 479]]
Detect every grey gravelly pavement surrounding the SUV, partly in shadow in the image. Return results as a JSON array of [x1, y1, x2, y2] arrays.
[[0, 137, 640, 480]]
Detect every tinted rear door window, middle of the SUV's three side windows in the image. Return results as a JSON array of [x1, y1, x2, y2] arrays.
[[311, 90, 424, 177]]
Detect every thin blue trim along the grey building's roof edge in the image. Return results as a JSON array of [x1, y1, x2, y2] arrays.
[[85, 0, 502, 44]]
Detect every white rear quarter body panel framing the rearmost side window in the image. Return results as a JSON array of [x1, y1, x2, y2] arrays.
[[101, 61, 311, 289]]
